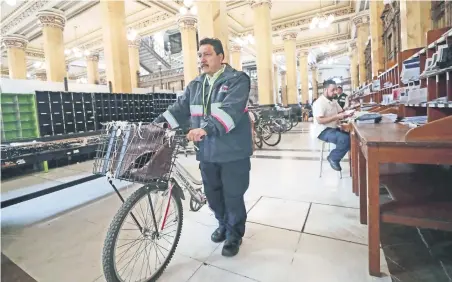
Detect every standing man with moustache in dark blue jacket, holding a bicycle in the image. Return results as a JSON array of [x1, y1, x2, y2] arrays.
[[157, 38, 252, 256]]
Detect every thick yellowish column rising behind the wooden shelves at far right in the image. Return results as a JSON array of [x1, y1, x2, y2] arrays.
[[400, 0, 432, 51]]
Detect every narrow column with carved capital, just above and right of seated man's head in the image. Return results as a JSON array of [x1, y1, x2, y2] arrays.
[[352, 10, 369, 85]]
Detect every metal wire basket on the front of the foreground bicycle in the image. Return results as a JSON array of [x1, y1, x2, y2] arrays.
[[93, 121, 177, 184]]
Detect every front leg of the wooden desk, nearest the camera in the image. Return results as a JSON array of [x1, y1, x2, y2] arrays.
[[367, 148, 381, 276]]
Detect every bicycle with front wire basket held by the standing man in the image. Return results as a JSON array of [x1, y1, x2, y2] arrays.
[[93, 122, 206, 282]]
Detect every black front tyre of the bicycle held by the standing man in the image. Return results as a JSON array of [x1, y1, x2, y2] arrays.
[[102, 186, 183, 282]]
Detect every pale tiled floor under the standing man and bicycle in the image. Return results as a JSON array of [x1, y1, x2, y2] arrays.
[[2, 125, 448, 282]]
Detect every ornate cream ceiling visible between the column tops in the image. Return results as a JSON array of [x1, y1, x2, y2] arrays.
[[0, 0, 362, 78]]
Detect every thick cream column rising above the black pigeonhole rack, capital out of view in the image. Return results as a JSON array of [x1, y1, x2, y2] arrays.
[[100, 0, 132, 93]]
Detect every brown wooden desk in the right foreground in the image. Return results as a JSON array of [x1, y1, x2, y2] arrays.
[[351, 120, 452, 276]]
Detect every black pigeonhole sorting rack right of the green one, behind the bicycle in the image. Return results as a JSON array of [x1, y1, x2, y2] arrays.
[[36, 91, 177, 137]]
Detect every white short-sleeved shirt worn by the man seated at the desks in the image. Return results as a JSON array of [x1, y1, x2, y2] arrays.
[[312, 95, 342, 137]]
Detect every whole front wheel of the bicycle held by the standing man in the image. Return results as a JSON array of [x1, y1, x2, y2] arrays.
[[102, 186, 183, 282]]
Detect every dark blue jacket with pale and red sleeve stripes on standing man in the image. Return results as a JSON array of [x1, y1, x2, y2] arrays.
[[159, 65, 252, 163]]
